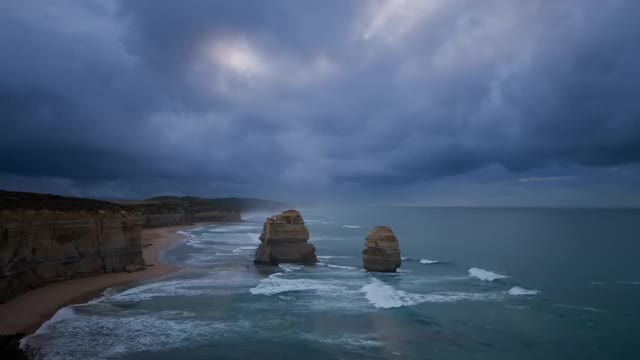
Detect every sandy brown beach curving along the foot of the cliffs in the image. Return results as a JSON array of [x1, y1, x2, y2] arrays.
[[0, 223, 211, 335]]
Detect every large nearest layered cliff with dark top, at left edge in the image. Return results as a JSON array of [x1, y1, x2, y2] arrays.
[[0, 191, 144, 303]]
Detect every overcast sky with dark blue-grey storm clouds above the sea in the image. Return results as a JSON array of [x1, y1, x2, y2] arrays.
[[0, 0, 640, 206]]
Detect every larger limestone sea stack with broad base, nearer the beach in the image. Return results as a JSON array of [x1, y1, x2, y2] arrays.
[[254, 210, 318, 265]]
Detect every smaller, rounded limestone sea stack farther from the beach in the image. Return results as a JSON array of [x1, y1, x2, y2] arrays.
[[362, 226, 402, 272]]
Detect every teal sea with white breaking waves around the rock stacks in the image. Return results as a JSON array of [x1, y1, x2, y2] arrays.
[[28, 208, 640, 360]]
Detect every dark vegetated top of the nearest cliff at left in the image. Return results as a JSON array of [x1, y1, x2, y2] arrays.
[[0, 190, 125, 212]]
